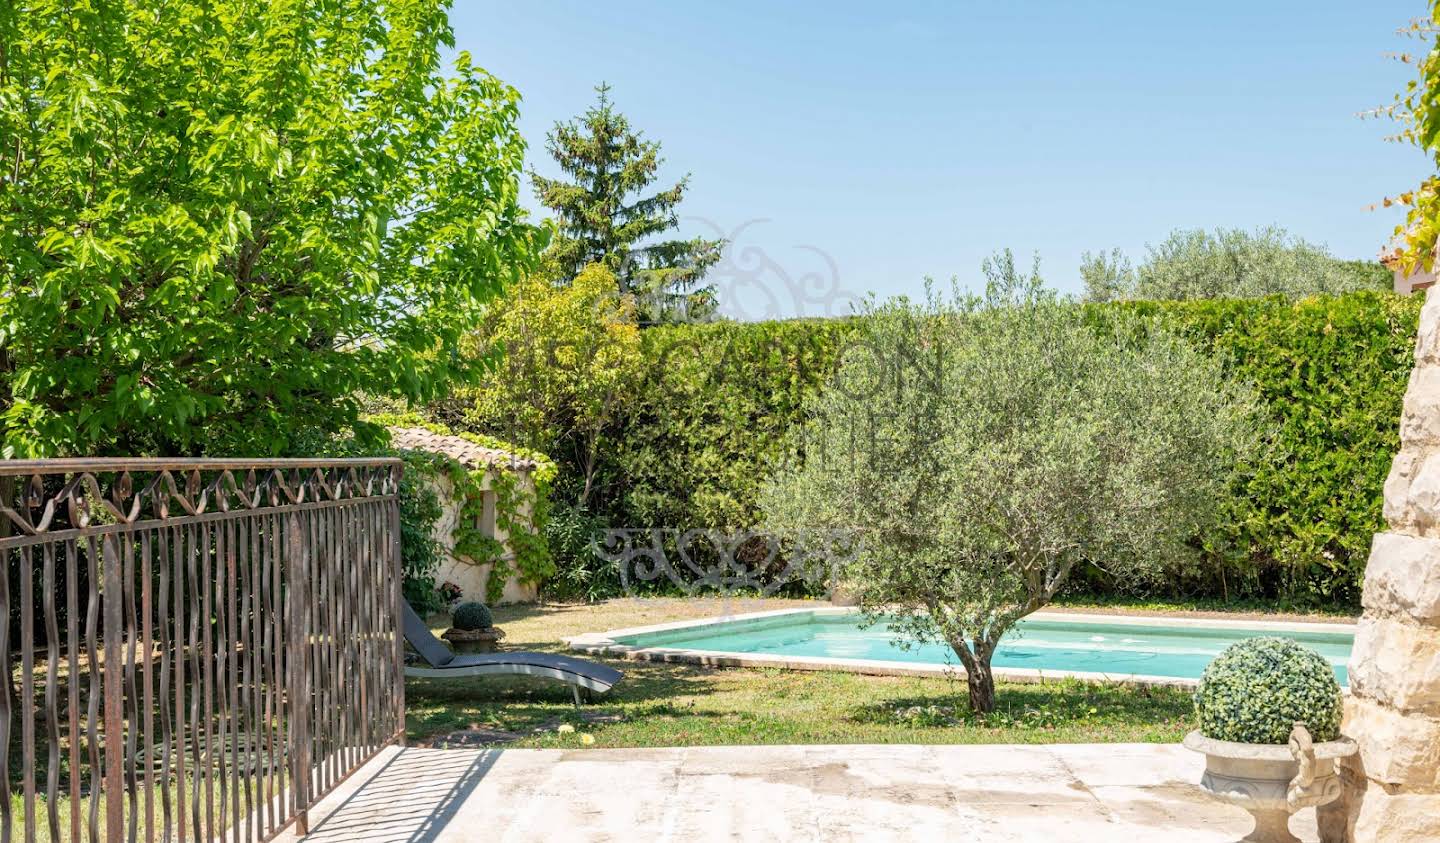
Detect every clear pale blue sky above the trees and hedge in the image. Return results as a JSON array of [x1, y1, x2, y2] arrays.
[[452, 0, 1428, 316]]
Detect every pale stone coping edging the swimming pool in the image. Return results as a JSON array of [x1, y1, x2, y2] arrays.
[[564, 607, 1355, 693]]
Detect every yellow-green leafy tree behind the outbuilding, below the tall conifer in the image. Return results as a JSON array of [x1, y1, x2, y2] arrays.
[[449, 265, 641, 510]]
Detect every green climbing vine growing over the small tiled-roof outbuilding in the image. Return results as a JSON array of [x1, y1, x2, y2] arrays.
[[370, 414, 556, 601]]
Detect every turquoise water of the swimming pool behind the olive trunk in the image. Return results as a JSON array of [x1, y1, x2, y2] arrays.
[[616, 612, 1354, 684]]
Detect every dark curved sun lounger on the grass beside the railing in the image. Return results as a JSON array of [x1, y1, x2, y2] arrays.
[[403, 602, 625, 705]]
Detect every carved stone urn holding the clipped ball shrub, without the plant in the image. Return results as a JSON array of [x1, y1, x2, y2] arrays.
[[1185, 723, 1355, 843]]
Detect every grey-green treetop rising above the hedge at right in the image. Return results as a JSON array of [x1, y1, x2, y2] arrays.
[[1080, 226, 1391, 301]]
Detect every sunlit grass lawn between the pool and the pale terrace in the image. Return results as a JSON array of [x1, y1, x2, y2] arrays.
[[406, 599, 1191, 748]]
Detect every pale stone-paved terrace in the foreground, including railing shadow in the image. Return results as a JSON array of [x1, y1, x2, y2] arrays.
[[278, 744, 1316, 843]]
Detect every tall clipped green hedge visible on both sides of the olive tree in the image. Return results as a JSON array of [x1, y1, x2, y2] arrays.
[[584, 293, 1421, 604]]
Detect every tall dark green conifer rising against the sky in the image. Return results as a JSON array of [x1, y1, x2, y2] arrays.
[[530, 85, 724, 323]]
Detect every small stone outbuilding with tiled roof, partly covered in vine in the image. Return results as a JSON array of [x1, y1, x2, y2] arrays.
[[389, 427, 539, 604]]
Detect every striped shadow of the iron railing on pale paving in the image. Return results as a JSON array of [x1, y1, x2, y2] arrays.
[[305, 748, 500, 843]]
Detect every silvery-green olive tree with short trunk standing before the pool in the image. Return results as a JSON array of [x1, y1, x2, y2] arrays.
[[760, 252, 1259, 712]]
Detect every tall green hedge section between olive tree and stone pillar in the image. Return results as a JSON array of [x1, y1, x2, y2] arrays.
[[1090, 293, 1423, 605]]
